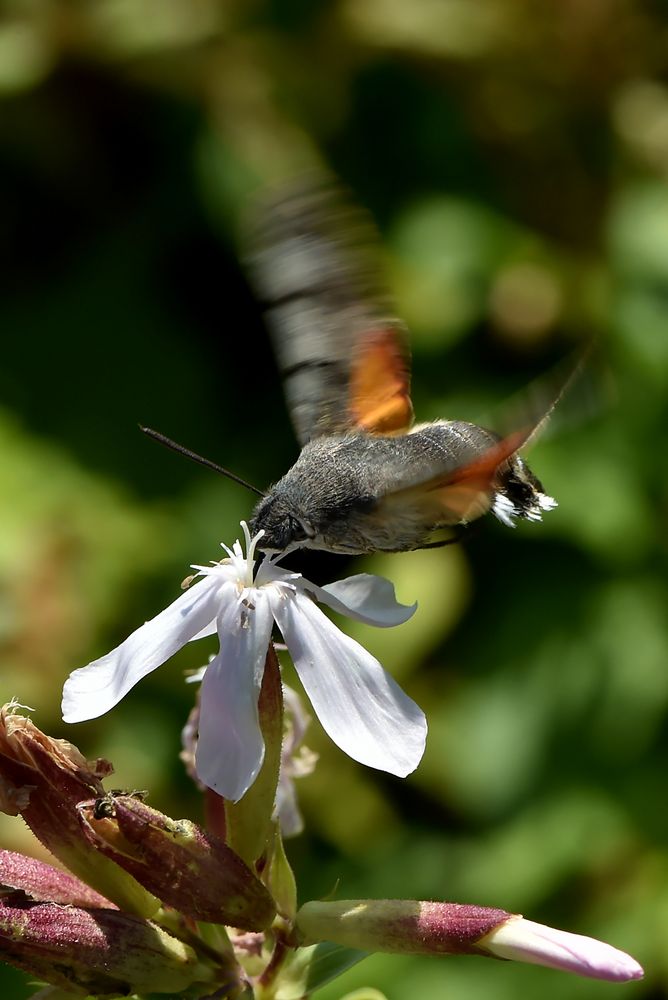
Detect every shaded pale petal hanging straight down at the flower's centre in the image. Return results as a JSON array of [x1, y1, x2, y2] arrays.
[[195, 589, 273, 802]]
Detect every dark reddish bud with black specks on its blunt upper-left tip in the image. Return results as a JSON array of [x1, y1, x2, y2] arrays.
[[79, 795, 276, 930]]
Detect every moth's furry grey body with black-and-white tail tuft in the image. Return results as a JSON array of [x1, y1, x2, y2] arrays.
[[252, 420, 551, 554]]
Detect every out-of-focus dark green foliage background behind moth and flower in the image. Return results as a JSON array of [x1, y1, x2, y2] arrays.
[[0, 0, 668, 1000]]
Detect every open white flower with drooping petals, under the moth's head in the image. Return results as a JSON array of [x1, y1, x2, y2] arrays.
[[62, 522, 427, 801]]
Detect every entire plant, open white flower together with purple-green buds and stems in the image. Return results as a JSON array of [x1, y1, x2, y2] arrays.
[[0, 525, 642, 1000]]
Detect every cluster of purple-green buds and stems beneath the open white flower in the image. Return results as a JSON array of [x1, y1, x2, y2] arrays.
[[0, 705, 642, 1000]]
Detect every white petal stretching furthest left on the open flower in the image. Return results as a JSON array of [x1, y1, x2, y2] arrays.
[[62, 573, 234, 722]]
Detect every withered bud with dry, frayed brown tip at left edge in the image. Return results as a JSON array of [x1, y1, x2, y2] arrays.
[[0, 704, 159, 916]]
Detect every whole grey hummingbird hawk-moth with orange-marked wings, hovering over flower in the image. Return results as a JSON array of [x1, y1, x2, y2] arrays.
[[248, 183, 556, 554]]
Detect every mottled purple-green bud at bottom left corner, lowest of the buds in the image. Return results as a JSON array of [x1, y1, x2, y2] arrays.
[[0, 891, 214, 996]]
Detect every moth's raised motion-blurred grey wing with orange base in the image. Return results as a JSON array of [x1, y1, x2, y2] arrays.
[[248, 179, 413, 445]]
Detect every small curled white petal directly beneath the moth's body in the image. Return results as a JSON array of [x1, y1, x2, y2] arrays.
[[303, 573, 417, 628]]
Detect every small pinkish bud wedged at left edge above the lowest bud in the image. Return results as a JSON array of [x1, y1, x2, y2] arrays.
[[0, 850, 116, 910]]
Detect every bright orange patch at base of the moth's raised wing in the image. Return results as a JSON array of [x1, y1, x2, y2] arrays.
[[350, 327, 413, 434]]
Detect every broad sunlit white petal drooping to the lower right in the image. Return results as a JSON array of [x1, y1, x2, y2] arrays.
[[271, 590, 427, 777]]
